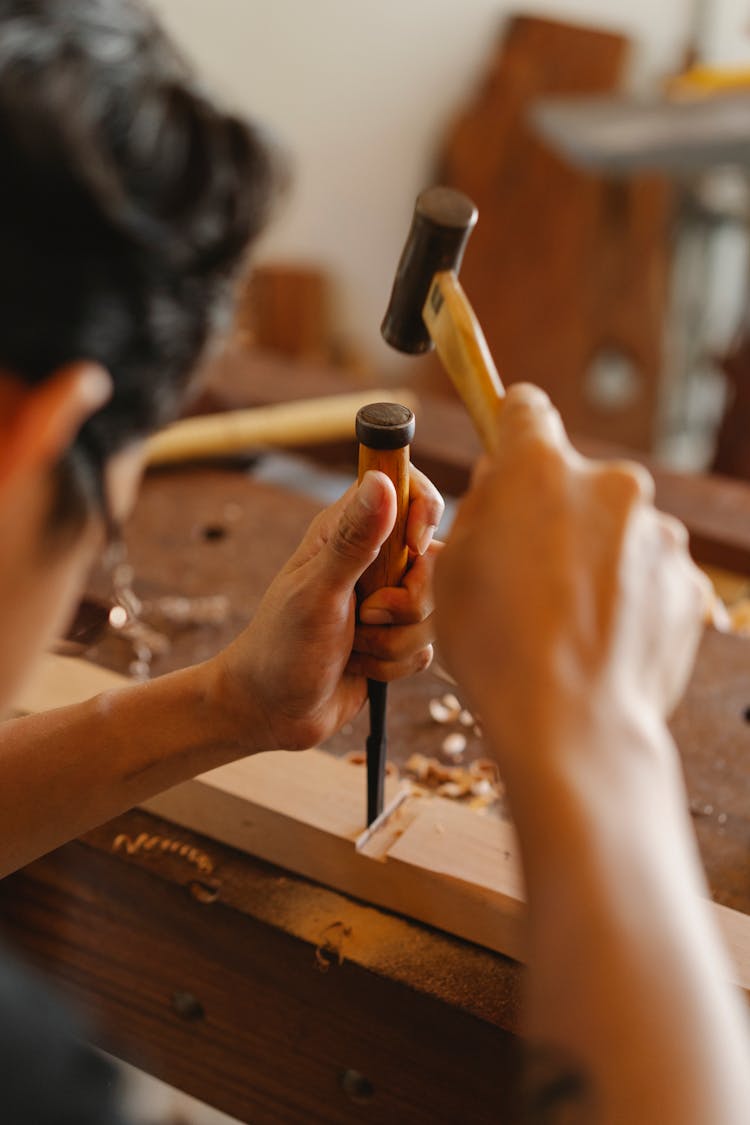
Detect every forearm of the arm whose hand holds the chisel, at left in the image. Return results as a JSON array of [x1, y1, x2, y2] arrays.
[[0, 662, 258, 875]]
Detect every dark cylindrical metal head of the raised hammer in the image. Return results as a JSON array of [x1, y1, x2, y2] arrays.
[[380, 188, 477, 354]]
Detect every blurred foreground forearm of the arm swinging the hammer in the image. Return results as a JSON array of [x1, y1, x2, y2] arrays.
[[490, 721, 750, 1125]]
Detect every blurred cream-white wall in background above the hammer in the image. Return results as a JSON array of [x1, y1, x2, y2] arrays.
[[146, 0, 728, 369]]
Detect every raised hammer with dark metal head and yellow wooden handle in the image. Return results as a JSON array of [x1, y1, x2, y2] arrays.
[[381, 187, 505, 451]]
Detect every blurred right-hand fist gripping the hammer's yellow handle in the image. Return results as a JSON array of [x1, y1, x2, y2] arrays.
[[435, 385, 708, 787]]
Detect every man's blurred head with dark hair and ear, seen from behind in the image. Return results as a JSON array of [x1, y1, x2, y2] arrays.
[[0, 0, 275, 698]]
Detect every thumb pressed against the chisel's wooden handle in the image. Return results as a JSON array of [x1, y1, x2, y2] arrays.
[[320, 470, 396, 593]]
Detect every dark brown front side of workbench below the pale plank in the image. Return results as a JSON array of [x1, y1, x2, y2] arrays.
[[0, 813, 519, 1125]]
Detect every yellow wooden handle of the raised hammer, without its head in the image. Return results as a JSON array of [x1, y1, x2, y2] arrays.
[[422, 270, 505, 452]]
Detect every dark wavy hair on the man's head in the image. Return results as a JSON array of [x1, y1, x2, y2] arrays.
[[0, 0, 281, 523]]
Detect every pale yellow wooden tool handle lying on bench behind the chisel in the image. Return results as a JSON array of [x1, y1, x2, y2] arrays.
[[146, 388, 414, 465]]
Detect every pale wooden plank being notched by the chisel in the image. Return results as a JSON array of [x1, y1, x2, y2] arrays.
[[14, 657, 750, 992]]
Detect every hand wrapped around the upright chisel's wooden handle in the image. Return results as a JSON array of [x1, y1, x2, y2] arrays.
[[213, 467, 443, 753]]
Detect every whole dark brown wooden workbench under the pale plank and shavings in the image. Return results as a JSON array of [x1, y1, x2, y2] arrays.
[[0, 364, 750, 1125]]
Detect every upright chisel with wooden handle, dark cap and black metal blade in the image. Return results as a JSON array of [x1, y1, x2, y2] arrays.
[[355, 403, 414, 825]]
